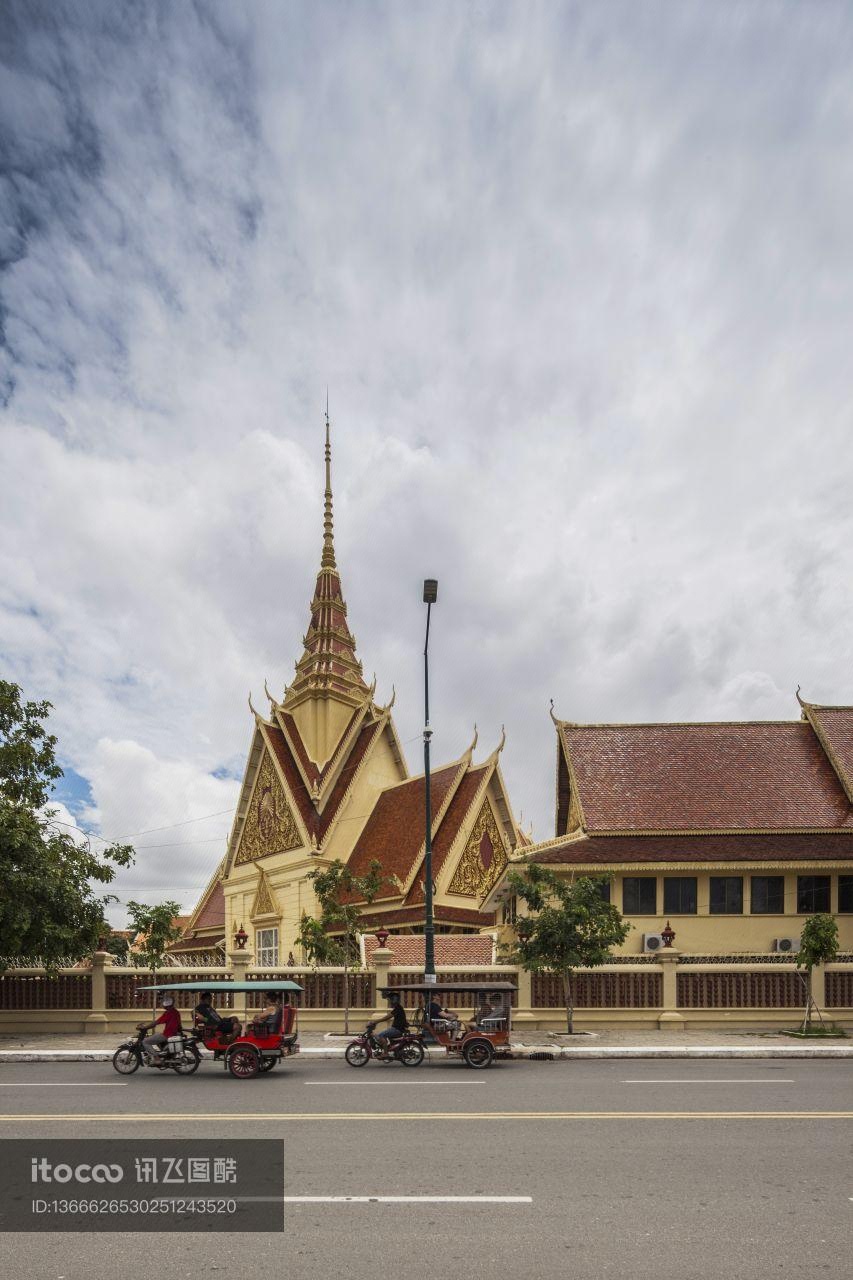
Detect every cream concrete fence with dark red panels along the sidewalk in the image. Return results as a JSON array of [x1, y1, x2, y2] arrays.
[[0, 948, 853, 1036]]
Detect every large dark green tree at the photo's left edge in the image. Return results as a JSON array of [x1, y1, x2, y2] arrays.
[[0, 680, 133, 970]]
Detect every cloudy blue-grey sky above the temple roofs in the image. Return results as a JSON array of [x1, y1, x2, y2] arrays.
[[0, 0, 853, 923]]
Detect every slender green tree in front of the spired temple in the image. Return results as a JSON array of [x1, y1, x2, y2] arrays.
[[296, 858, 386, 1036]]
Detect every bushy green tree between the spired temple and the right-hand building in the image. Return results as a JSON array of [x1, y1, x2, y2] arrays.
[[507, 863, 630, 1034]]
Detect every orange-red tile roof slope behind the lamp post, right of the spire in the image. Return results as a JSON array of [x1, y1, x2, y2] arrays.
[[347, 764, 460, 881]]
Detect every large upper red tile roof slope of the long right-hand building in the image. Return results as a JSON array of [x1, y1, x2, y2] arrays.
[[560, 721, 853, 833]]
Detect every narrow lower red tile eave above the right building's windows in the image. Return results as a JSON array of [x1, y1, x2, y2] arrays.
[[529, 831, 853, 867]]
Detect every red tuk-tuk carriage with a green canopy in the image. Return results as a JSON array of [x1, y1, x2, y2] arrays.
[[140, 979, 302, 1080]]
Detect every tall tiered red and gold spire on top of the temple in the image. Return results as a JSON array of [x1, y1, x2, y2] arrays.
[[280, 407, 373, 710]]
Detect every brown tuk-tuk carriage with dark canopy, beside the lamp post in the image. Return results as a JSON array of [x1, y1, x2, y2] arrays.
[[382, 982, 517, 1070]]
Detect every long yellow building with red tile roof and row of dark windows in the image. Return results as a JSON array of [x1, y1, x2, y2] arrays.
[[479, 692, 853, 956]]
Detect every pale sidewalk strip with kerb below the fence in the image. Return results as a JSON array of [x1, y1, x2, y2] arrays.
[[0, 1030, 853, 1065]]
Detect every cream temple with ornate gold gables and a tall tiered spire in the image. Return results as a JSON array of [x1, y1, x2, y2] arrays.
[[175, 413, 524, 965]]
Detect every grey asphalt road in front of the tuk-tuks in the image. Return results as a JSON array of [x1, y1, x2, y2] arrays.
[[0, 1060, 853, 1280]]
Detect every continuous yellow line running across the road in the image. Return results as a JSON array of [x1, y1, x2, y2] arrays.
[[0, 1111, 853, 1124]]
